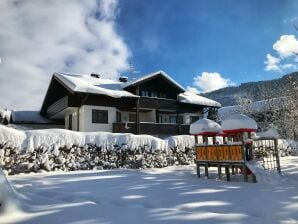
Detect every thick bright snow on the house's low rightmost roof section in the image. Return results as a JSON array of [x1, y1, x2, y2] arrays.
[[178, 92, 221, 107]]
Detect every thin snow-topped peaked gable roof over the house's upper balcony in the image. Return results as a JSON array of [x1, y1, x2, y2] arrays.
[[123, 71, 185, 92]]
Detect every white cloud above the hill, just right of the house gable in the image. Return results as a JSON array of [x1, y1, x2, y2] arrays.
[[187, 72, 236, 92]]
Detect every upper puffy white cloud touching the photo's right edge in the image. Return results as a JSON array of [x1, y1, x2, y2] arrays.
[[273, 35, 298, 58]]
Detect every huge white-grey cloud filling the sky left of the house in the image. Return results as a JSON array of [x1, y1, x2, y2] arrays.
[[0, 0, 130, 109]]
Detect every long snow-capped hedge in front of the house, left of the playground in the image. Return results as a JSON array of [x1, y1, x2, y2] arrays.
[[0, 126, 194, 174]]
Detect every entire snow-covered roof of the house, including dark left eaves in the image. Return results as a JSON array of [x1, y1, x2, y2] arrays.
[[41, 71, 221, 119]]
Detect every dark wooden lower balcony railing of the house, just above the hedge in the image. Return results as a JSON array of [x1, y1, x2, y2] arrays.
[[113, 122, 189, 135]]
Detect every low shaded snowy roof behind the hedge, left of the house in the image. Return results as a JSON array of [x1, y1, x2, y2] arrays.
[[11, 110, 52, 124]]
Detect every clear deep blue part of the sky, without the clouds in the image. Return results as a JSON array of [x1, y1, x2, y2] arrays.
[[117, 0, 298, 90]]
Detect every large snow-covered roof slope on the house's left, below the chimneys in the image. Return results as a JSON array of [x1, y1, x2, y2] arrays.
[[54, 73, 137, 98]]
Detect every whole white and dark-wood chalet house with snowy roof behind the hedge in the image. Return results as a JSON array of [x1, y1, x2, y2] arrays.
[[41, 71, 221, 136]]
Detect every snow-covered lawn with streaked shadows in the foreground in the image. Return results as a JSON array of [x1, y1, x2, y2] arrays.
[[0, 157, 298, 224]]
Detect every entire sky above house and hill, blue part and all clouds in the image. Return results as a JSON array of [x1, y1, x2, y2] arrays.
[[0, 0, 298, 109]]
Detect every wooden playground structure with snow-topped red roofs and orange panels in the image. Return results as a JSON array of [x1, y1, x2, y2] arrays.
[[190, 115, 280, 182]]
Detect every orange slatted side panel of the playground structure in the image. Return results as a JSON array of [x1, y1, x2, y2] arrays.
[[196, 145, 244, 162]]
